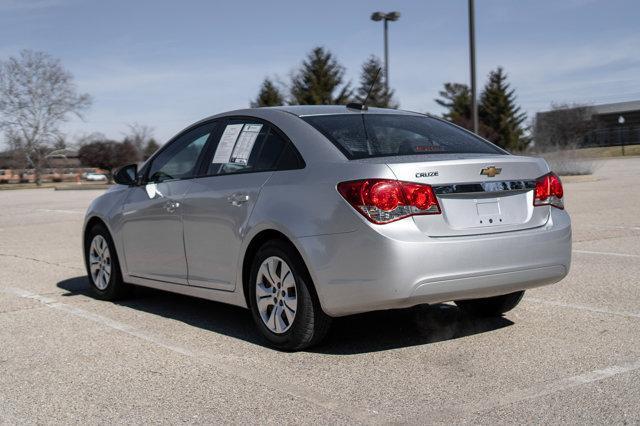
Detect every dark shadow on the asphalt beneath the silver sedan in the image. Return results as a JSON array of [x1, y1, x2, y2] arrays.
[[57, 276, 513, 355]]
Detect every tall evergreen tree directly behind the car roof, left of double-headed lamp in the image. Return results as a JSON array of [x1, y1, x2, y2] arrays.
[[290, 47, 352, 105]]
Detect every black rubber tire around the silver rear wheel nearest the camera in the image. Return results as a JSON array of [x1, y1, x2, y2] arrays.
[[247, 240, 331, 351]]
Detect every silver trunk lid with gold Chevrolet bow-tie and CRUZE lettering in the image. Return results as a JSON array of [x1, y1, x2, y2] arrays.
[[376, 154, 549, 237]]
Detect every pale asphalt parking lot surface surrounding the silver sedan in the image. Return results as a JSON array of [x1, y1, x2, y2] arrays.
[[0, 157, 640, 424]]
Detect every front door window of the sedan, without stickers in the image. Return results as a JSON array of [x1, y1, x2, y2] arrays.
[[148, 123, 215, 182]]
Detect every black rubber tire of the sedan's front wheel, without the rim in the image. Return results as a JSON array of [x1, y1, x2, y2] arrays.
[[84, 223, 131, 301]]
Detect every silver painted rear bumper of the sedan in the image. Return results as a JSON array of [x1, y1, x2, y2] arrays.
[[296, 209, 571, 316]]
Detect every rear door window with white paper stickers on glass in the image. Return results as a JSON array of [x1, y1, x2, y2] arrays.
[[207, 120, 287, 175]]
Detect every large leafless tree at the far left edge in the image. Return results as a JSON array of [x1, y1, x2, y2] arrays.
[[0, 50, 91, 184]]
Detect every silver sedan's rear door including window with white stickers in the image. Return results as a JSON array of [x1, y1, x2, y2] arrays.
[[183, 118, 300, 291]]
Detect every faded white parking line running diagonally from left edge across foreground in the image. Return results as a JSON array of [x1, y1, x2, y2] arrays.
[[0, 287, 377, 423]]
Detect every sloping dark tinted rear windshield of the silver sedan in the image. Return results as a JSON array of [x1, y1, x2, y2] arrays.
[[302, 114, 505, 160]]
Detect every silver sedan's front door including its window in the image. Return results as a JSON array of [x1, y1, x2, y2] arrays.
[[122, 123, 214, 284]]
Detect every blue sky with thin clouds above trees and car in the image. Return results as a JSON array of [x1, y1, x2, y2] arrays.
[[0, 0, 640, 145]]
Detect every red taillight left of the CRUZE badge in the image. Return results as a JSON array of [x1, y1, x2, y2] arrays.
[[338, 179, 440, 224]]
